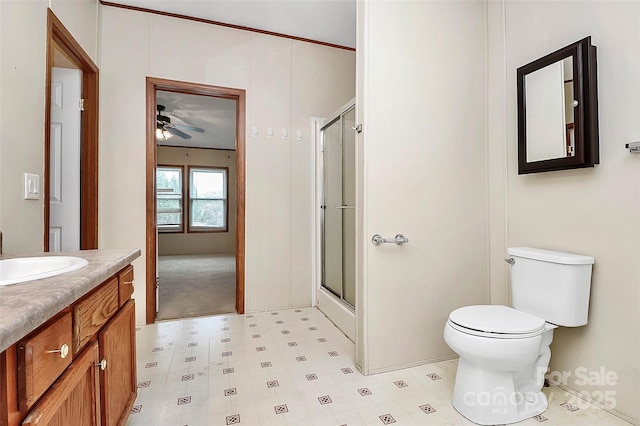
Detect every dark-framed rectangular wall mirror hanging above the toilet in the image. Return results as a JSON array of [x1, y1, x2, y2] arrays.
[[517, 37, 600, 174]]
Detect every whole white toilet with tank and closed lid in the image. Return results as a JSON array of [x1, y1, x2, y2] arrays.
[[444, 247, 594, 425]]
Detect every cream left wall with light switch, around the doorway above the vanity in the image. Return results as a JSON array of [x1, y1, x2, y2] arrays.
[[0, 0, 99, 254]]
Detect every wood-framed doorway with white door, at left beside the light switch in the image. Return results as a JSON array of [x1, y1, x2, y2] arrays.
[[43, 9, 98, 251]]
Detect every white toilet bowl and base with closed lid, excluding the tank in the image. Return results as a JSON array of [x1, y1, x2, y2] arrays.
[[444, 305, 555, 425]]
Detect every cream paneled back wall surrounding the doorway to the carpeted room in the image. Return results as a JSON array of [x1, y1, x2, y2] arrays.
[[100, 6, 355, 322]]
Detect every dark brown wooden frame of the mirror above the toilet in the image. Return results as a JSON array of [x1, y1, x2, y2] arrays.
[[517, 37, 600, 175]]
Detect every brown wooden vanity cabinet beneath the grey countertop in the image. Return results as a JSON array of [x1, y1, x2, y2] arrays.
[[0, 265, 137, 426]]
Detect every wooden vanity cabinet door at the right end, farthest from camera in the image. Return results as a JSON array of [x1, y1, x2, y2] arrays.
[[98, 300, 137, 426]]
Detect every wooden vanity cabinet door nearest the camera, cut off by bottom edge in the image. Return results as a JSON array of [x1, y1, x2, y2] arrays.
[[22, 341, 100, 426]]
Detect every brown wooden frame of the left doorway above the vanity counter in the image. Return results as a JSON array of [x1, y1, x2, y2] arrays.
[[42, 9, 99, 251]]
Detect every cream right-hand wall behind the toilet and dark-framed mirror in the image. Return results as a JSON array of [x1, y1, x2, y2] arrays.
[[488, 1, 640, 422]]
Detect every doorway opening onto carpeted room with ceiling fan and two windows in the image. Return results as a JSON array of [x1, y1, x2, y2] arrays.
[[156, 137, 237, 321]]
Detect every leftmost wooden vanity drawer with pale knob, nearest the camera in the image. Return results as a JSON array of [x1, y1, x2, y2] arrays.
[[18, 312, 72, 411]]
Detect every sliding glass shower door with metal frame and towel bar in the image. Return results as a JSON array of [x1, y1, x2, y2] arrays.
[[320, 106, 356, 308]]
